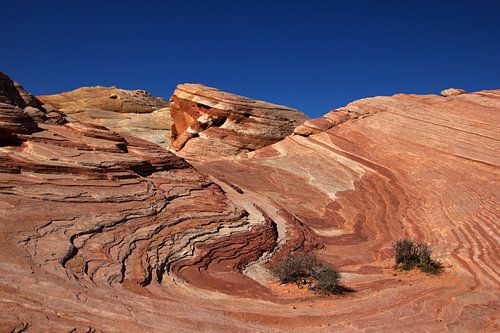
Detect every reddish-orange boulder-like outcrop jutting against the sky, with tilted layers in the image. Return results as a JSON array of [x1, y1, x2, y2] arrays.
[[170, 84, 307, 160]]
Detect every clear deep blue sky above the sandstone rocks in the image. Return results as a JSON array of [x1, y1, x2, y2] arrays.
[[0, 0, 500, 117]]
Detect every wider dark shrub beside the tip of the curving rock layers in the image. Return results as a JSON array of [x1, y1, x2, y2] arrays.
[[272, 253, 352, 294]]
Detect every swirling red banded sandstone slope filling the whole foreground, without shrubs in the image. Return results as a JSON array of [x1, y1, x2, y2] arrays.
[[0, 73, 500, 332]]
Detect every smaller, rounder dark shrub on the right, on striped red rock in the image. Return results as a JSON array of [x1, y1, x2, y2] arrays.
[[392, 239, 443, 274]]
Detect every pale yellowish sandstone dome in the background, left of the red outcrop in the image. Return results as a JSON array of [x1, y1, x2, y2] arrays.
[[38, 87, 172, 148]]
